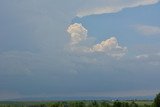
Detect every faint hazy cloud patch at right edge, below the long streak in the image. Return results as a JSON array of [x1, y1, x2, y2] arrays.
[[136, 25, 160, 36]]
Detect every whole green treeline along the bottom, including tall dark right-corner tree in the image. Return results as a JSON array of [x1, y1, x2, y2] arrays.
[[0, 94, 160, 107]]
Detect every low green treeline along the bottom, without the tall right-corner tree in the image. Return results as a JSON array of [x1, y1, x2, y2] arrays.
[[0, 101, 152, 107]]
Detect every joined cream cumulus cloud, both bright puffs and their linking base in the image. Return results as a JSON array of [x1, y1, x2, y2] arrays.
[[67, 23, 127, 57]]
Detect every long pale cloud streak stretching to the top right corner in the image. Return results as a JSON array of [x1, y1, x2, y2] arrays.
[[77, 0, 160, 17]]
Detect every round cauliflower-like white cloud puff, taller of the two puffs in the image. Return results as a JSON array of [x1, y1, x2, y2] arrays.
[[67, 23, 87, 45]]
